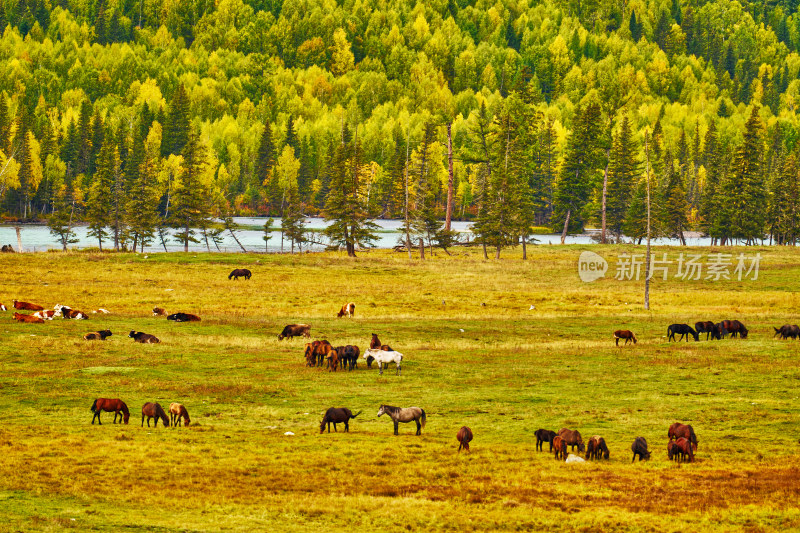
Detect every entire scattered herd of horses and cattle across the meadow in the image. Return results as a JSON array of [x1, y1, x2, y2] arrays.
[[0, 269, 800, 462]]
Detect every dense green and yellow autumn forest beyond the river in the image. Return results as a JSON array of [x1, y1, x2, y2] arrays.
[[0, 0, 800, 254]]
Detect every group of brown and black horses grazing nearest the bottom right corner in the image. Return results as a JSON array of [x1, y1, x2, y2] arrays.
[[534, 422, 697, 463]]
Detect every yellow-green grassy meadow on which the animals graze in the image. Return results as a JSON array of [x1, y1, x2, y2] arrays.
[[0, 246, 800, 531]]
